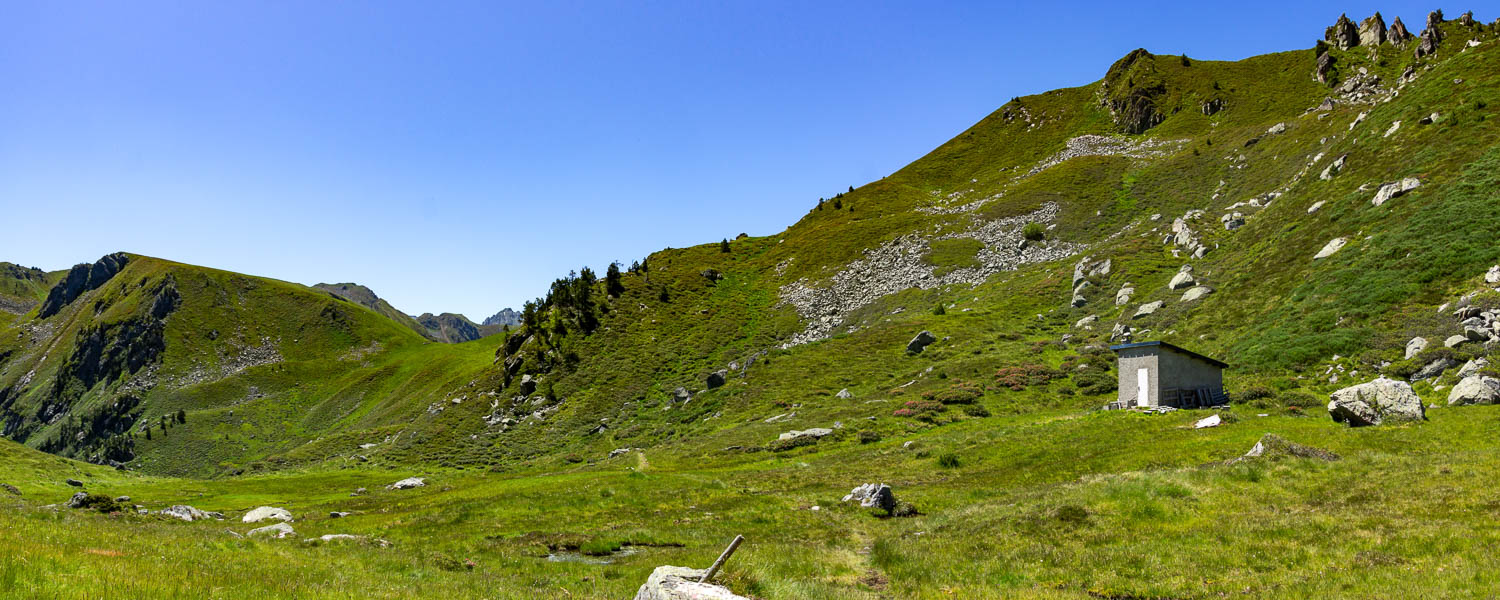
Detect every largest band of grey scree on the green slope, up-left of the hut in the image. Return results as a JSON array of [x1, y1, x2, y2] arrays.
[[780, 203, 1083, 348]]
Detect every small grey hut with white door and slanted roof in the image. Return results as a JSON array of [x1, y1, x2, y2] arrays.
[[1107, 342, 1229, 408]]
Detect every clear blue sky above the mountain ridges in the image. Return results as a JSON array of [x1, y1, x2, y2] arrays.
[[0, 0, 1452, 321]]
